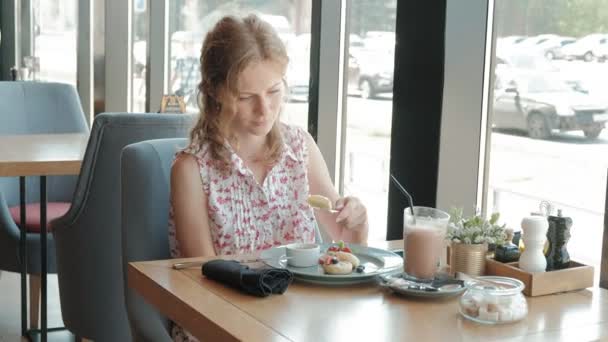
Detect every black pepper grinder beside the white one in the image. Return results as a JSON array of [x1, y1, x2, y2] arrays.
[[546, 209, 572, 271]]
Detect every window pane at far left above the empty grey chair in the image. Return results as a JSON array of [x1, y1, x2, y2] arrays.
[[32, 0, 78, 85]]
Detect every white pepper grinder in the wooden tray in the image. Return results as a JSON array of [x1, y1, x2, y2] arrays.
[[519, 216, 549, 273]]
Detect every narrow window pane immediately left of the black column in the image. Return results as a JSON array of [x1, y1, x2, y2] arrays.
[[343, 0, 397, 240]]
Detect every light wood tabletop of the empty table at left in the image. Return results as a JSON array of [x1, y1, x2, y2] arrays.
[[0, 134, 89, 177]]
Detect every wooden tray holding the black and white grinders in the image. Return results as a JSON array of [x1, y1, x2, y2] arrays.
[[486, 258, 593, 297]]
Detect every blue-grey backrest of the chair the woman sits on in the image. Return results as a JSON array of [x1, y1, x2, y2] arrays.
[[121, 139, 188, 341]]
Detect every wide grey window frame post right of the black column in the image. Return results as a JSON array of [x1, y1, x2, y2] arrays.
[[437, 0, 494, 218]]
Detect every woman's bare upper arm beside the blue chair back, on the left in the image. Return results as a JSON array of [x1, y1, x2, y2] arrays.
[[171, 154, 215, 258]]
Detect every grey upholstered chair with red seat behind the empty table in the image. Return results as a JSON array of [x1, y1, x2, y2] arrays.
[[0, 82, 89, 326]]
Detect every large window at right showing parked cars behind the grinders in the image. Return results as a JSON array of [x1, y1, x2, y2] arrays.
[[488, 0, 608, 266]]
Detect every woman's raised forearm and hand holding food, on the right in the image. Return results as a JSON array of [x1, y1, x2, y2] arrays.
[[306, 133, 369, 244]]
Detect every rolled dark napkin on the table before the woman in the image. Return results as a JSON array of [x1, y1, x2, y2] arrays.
[[202, 259, 293, 297]]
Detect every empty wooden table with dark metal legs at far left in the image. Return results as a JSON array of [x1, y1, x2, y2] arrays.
[[0, 134, 88, 341]]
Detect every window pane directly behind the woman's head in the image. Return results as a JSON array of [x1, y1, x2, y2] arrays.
[[169, 0, 311, 128]]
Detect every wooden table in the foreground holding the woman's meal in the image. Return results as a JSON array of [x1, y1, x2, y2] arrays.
[[128, 241, 608, 341]]
